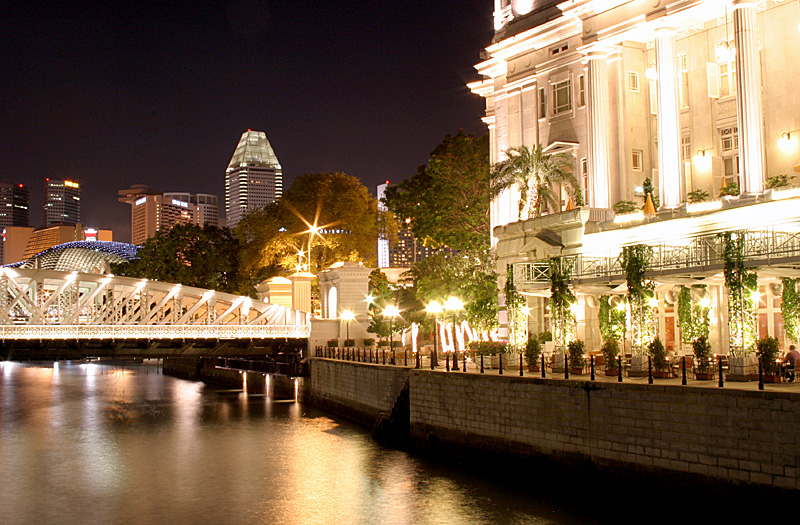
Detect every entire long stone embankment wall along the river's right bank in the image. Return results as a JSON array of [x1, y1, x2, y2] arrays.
[[309, 359, 800, 490]]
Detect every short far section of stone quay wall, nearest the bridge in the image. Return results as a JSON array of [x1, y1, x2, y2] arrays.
[[306, 358, 412, 427]]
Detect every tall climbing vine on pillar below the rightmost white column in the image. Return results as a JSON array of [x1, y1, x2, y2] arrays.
[[719, 231, 758, 357]]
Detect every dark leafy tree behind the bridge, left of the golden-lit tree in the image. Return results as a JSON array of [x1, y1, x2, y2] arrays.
[[113, 224, 244, 293]]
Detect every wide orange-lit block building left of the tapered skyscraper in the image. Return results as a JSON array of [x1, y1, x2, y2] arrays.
[[117, 184, 219, 245]]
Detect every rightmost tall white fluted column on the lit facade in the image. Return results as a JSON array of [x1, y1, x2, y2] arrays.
[[733, 0, 764, 194]]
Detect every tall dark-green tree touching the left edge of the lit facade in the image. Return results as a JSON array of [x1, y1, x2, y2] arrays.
[[383, 130, 490, 250]]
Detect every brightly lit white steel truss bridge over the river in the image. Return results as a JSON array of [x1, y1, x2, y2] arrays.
[[0, 267, 310, 359]]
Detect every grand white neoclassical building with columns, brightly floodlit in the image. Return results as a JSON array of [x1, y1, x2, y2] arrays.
[[470, 0, 800, 353]]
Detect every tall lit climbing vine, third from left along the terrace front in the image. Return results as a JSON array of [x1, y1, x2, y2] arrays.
[[622, 244, 655, 352]]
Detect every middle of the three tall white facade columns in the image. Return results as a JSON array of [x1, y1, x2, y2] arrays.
[[655, 27, 684, 208]]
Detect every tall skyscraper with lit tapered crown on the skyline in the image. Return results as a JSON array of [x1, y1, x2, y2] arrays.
[[225, 130, 283, 228]]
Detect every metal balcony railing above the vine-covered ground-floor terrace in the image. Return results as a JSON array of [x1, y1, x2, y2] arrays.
[[514, 230, 800, 288]]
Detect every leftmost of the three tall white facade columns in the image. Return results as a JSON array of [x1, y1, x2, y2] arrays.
[[586, 48, 611, 208]]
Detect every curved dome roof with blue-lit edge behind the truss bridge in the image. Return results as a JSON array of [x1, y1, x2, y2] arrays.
[[8, 241, 140, 273]]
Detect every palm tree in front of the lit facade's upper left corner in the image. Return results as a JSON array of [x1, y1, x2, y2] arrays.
[[491, 144, 583, 219]]
